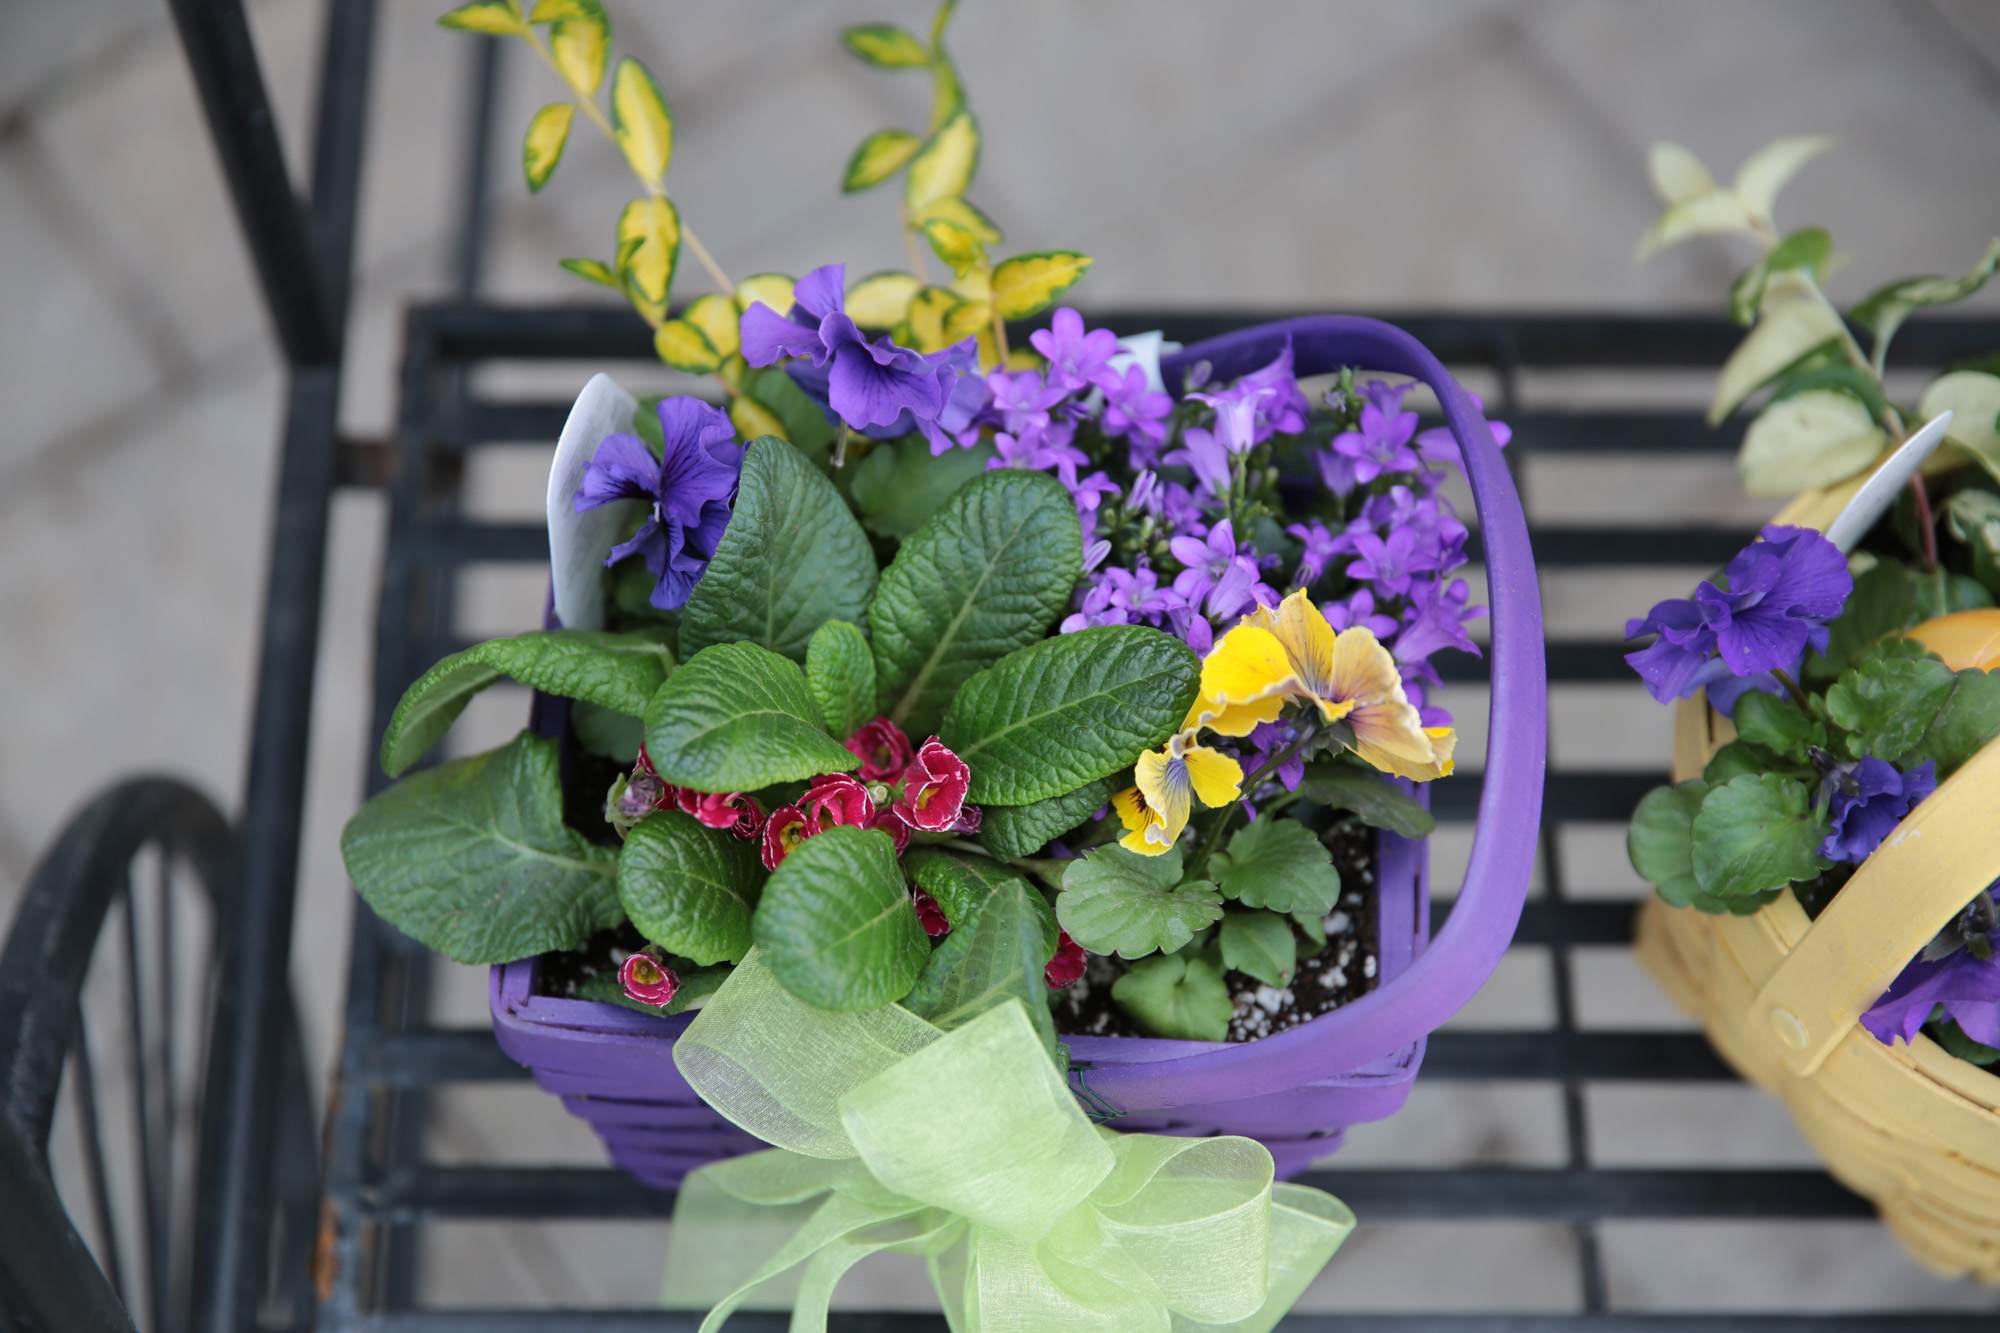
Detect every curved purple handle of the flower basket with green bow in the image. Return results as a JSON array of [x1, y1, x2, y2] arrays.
[[1090, 314, 1548, 1111]]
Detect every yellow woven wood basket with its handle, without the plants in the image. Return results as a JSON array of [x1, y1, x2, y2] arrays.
[[1636, 480, 2000, 1283]]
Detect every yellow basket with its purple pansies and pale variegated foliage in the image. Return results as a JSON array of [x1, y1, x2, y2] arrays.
[[1628, 138, 2000, 1281]]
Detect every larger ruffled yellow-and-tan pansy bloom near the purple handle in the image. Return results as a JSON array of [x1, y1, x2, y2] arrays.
[[1194, 588, 1458, 783]]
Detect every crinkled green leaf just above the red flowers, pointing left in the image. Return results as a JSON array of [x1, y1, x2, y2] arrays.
[[646, 642, 860, 791]]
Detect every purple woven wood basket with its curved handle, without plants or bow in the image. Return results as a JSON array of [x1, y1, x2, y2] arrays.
[[490, 316, 1548, 1189]]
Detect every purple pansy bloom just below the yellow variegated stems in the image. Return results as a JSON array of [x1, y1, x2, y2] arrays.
[[742, 264, 984, 454]]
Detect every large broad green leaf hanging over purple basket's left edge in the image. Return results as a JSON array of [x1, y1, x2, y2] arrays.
[[340, 731, 622, 965]]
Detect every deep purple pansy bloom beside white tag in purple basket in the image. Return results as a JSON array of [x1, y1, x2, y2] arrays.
[[576, 398, 744, 610]]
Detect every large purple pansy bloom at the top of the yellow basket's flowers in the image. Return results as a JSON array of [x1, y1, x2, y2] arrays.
[[1626, 524, 1854, 703]]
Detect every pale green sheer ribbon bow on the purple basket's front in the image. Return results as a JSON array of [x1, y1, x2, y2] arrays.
[[664, 951, 1354, 1333]]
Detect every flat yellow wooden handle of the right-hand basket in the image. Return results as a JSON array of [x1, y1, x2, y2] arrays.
[[1750, 743, 2000, 1075]]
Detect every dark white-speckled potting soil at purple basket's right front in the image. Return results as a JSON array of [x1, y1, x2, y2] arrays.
[[1052, 825, 1380, 1041]]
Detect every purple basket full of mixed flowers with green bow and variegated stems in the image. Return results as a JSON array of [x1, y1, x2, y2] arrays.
[[342, 0, 1540, 1329]]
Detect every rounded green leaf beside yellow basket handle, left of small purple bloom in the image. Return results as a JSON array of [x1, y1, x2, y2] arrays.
[[1692, 773, 1832, 899]]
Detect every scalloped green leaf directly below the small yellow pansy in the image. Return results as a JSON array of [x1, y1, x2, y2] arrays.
[[1056, 847, 1222, 959]]
